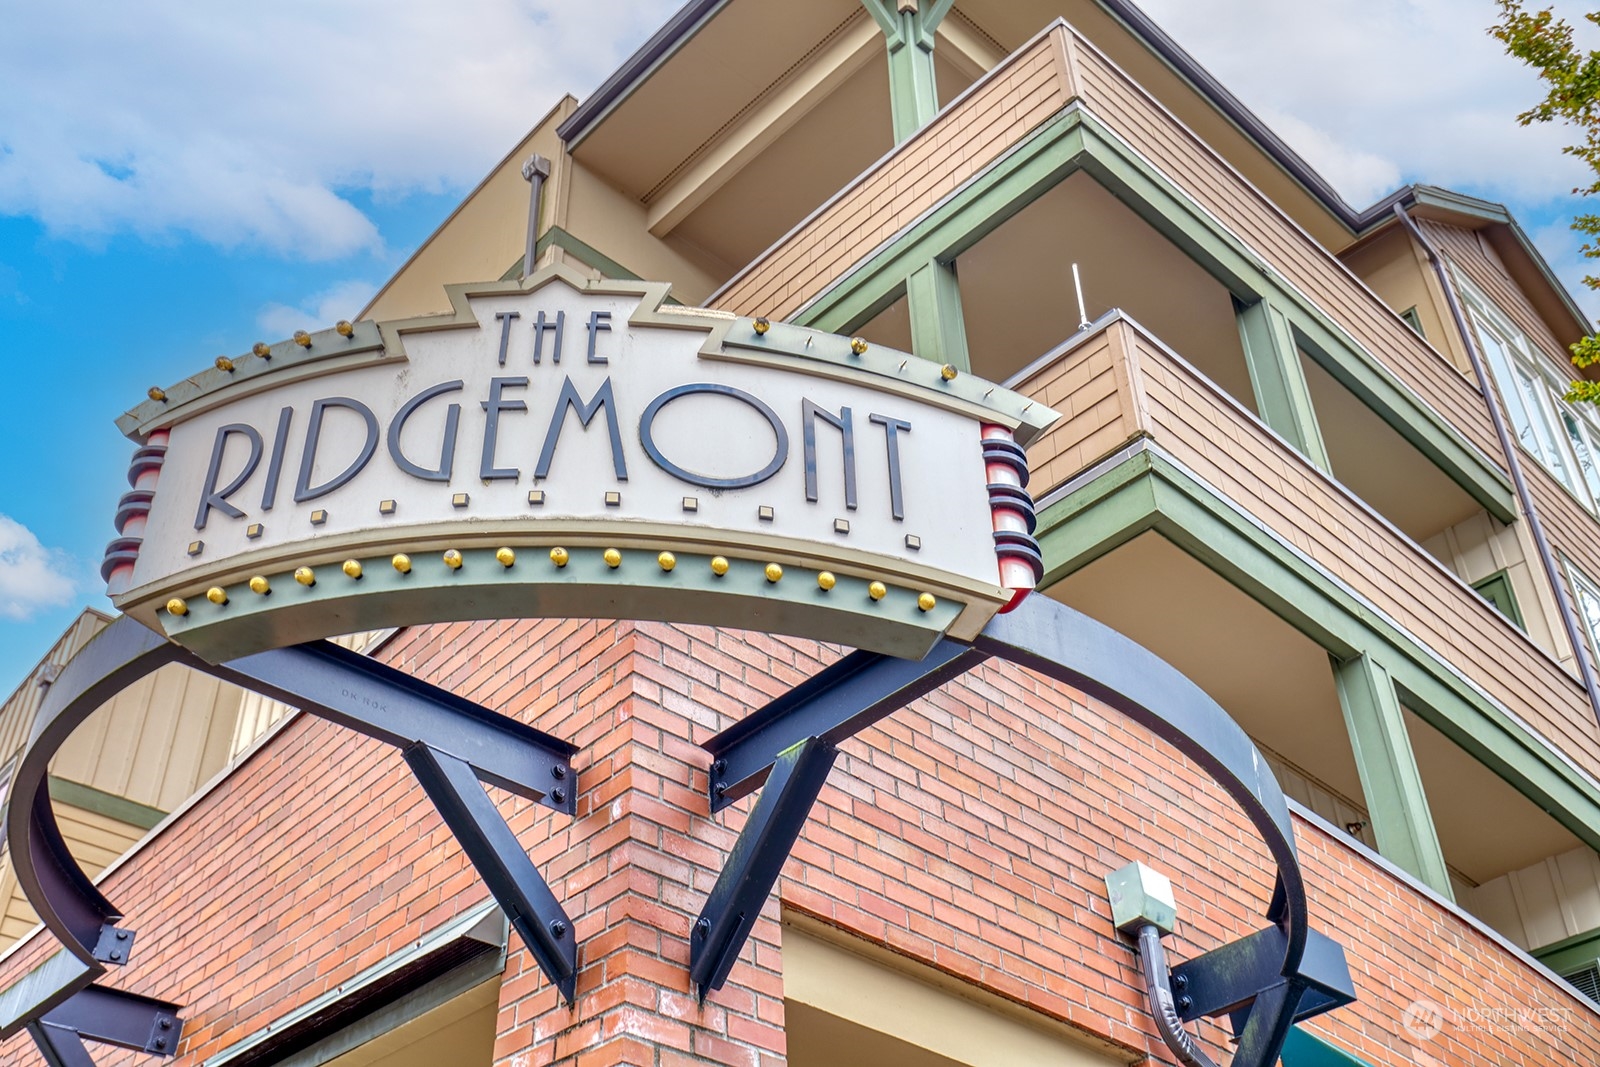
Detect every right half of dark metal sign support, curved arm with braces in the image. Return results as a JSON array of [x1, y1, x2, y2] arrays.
[[690, 593, 1324, 1067]]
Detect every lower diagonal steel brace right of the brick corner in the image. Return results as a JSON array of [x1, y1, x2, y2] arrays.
[[690, 737, 838, 1001]]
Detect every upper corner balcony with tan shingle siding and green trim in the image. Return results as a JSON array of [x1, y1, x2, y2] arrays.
[[709, 21, 1514, 524]]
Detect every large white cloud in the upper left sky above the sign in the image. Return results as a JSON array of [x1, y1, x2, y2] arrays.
[[0, 0, 675, 259]]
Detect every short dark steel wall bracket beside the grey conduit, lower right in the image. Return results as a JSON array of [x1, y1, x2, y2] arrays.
[[1173, 926, 1355, 1022]]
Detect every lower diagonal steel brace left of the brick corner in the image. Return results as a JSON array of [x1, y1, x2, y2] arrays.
[[405, 744, 578, 1003]]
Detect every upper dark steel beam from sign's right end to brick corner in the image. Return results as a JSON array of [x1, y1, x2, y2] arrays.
[[704, 640, 989, 814]]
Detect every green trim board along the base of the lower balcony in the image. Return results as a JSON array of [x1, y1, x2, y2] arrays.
[[1037, 440, 1600, 857]]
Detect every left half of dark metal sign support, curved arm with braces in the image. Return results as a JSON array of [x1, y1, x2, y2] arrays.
[[0, 616, 578, 1037]]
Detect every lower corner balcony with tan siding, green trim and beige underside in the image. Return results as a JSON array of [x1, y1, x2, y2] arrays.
[[1013, 312, 1600, 907]]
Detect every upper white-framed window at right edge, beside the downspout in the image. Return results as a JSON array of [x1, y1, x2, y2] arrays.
[[1456, 272, 1600, 512]]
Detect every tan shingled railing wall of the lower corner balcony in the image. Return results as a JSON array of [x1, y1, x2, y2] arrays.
[[1016, 312, 1600, 774]]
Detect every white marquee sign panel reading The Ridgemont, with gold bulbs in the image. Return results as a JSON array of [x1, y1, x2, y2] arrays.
[[96, 269, 1056, 661]]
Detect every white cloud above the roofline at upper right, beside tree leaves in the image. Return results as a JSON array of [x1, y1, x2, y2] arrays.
[[1142, 0, 1582, 208]]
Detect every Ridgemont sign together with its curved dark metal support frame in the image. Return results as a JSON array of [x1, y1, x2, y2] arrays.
[[9, 267, 1354, 1067]]
